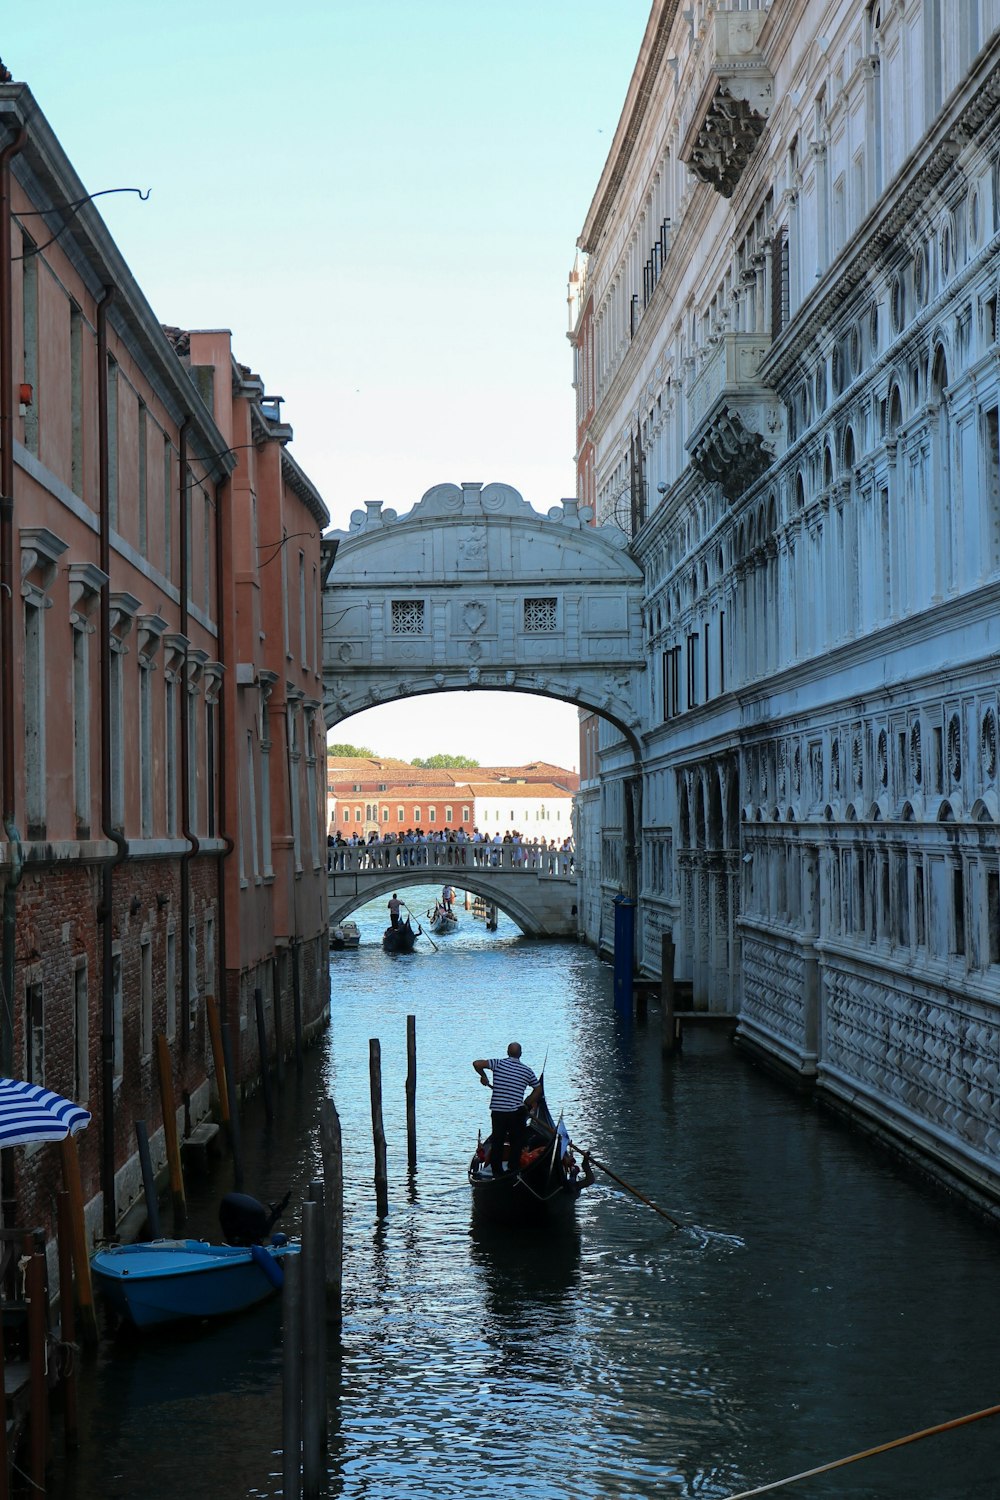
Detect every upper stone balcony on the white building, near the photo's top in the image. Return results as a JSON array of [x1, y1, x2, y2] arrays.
[[678, 9, 774, 198]]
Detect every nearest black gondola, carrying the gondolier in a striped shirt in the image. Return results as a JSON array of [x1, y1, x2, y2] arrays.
[[468, 1094, 594, 1224]]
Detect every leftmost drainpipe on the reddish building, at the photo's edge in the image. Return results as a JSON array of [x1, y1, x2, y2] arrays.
[[0, 128, 27, 1116]]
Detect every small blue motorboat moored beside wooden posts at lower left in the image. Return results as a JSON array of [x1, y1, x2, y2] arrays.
[[90, 1235, 300, 1328]]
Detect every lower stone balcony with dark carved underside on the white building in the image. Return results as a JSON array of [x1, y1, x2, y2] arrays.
[[687, 333, 786, 501]]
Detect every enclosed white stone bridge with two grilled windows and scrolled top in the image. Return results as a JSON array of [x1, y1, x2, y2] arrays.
[[324, 483, 645, 756]]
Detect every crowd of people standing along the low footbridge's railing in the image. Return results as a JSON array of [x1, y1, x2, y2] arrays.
[[327, 828, 574, 875]]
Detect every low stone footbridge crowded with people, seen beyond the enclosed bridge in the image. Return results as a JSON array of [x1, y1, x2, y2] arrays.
[[327, 840, 577, 938]]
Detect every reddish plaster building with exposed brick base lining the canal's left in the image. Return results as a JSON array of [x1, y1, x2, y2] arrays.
[[0, 83, 325, 1233]]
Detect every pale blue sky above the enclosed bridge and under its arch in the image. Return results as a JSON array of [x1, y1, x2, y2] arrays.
[[11, 0, 649, 767]]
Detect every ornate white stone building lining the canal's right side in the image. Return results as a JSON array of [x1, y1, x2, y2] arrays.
[[571, 0, 1000, 1200]]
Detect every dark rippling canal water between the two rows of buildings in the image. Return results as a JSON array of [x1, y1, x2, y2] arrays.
[[49, 890, 1000, 1500]]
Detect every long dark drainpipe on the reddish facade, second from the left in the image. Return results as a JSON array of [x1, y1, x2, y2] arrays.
[[97, 287, 129, 1239]]
